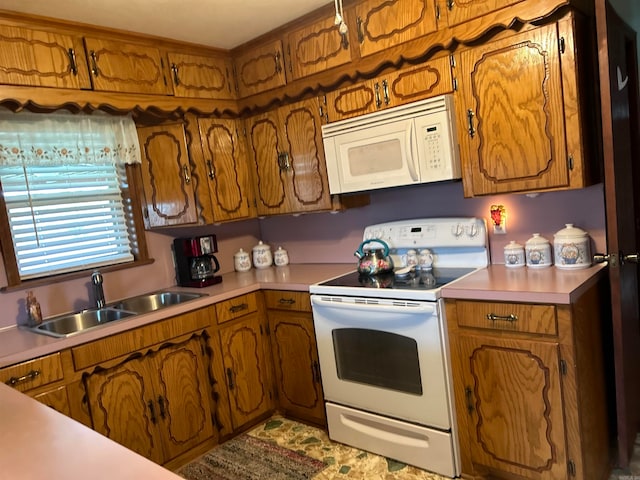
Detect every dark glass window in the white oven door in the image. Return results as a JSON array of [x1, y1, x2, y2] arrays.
[[333, 328, 422, 395]]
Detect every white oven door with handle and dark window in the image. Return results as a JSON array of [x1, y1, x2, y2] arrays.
[[311, 295, 451, 430]]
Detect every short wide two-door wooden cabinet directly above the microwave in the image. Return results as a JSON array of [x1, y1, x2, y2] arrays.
[[320, 56, 453, 122]]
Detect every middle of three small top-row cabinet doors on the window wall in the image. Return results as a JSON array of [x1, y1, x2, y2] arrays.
[[84, 37, 173, 95]]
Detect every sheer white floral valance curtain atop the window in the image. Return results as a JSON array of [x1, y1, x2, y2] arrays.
[[0, 112, 140, 166]]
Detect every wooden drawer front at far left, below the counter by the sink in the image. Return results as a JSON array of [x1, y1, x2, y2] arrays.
[[0, 353, 64, 392]]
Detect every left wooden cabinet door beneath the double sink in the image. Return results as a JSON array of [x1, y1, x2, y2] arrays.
[[84, 358, 163, 463]]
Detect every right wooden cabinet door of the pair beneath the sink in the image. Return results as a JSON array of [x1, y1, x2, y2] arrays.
[[154, 338, 213, 461]]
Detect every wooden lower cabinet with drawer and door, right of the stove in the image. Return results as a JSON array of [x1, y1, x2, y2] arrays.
[[446, 285, 609, 480]]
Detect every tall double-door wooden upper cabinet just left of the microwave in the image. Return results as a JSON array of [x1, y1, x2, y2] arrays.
[[247, 100, 331, 215]]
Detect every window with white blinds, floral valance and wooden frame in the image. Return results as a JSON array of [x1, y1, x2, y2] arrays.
[[0, 112, 146, 287]]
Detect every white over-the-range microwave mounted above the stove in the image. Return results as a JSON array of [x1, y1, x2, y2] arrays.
[[322, 95, 460, 194]]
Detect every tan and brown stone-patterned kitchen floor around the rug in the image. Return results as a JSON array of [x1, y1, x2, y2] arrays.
[[248, 416, 640, 480]]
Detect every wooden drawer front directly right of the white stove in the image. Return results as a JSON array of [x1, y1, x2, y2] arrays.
[[456, 301, 558, 335]]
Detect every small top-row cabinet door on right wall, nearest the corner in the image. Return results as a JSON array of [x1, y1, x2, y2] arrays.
[[234, 40, 286, 98]]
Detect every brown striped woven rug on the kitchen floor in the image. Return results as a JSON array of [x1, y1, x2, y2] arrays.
[[177, 435, 325, 480]]
